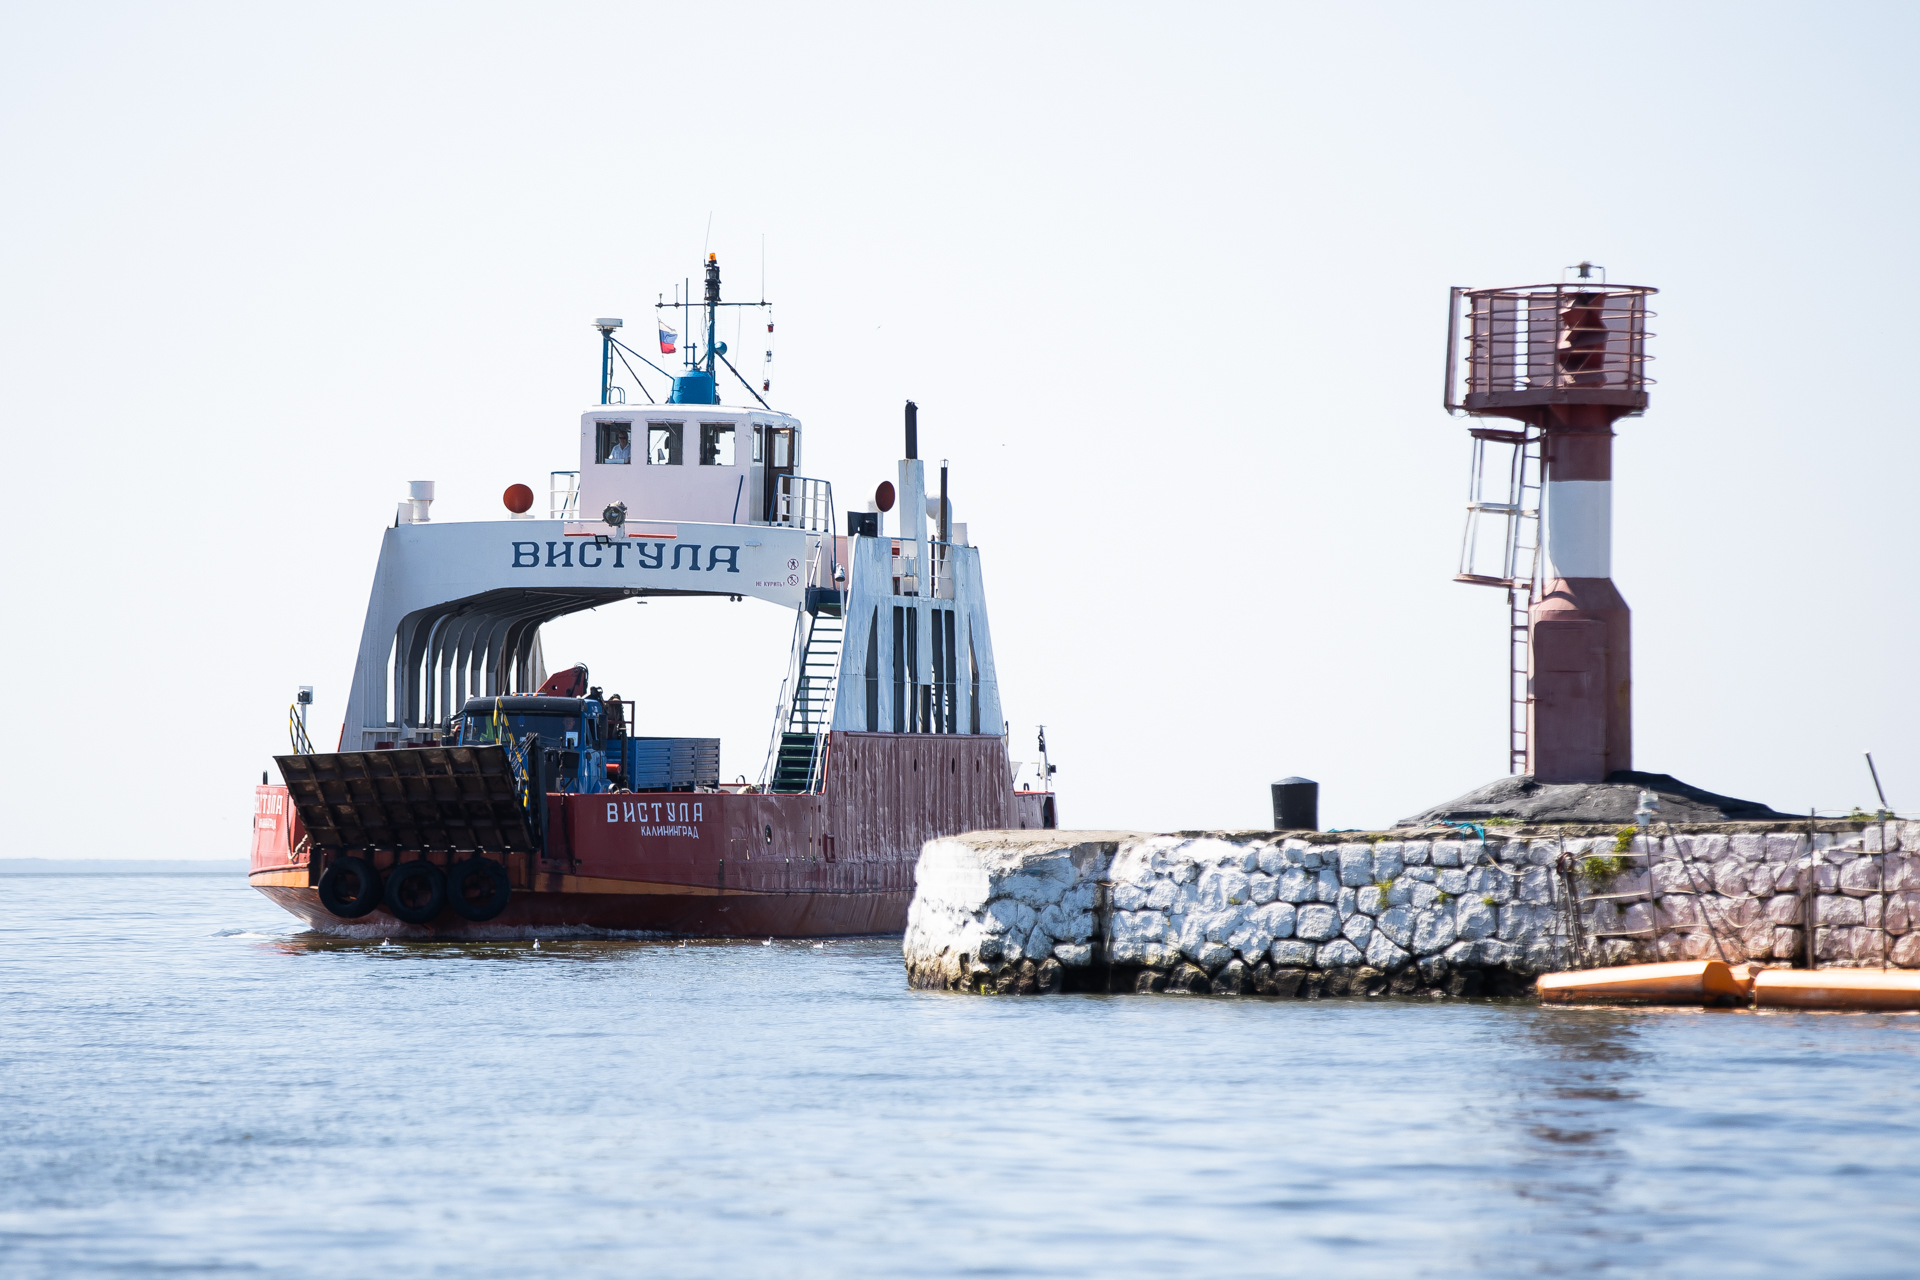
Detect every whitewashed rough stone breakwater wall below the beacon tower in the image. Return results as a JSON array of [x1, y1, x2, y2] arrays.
[[904, 821, 1920, 996]]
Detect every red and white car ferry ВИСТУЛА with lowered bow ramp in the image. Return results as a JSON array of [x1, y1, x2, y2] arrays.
[[250, 255, 1054, 938]]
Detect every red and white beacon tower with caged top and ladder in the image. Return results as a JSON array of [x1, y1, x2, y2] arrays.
[[1446, 263, 1655, 783]]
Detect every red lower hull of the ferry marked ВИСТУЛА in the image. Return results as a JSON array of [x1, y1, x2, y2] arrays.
[[252, 733, 1041, 938]]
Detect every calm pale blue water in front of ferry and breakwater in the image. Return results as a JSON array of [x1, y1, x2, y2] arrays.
[[0, 875, 1920, 1278]]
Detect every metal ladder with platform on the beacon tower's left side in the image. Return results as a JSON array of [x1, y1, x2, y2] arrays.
[[1453, 426, 1544, 773]]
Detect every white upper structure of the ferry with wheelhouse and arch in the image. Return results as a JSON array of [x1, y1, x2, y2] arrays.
[[340, 403, 1002, 791]]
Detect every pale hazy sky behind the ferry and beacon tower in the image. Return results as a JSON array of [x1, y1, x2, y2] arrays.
[[0, 4, 1920, 858]]
